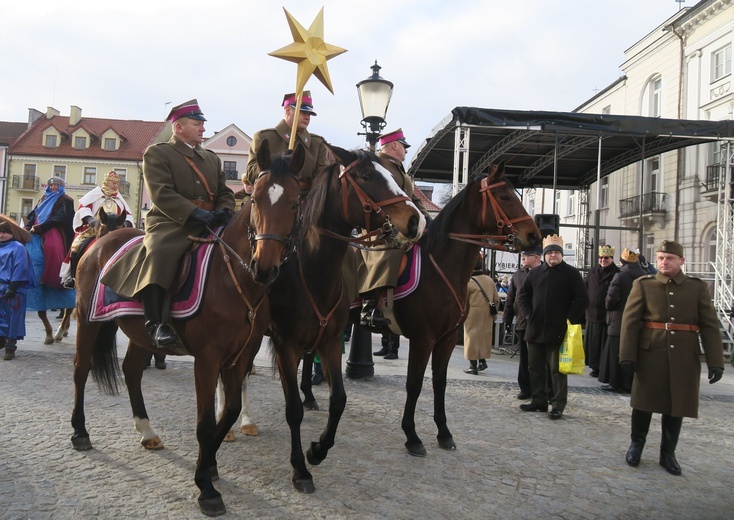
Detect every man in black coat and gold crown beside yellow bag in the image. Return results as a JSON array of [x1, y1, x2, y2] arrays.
[[519, 235, 589, 419]]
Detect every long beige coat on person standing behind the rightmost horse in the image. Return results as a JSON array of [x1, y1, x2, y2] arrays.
[[464, 274, 500, 359]]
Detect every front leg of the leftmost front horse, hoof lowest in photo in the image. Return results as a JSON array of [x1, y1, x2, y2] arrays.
[[194, 360, 229, 516]]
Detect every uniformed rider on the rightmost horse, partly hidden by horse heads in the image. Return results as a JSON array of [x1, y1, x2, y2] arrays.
[[357, 128, 430, 359]]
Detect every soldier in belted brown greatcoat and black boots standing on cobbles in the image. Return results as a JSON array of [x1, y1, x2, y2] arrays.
[[619, 240, 724, 475]]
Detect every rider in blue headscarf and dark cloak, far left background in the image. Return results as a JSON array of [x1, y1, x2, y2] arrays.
[[25, 177, 75, 289]]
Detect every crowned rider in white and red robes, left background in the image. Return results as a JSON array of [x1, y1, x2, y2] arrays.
[[59, 170, 135, 289]]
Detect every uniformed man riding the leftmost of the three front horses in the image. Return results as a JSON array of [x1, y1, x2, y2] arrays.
[[102, 99, 234, 348]]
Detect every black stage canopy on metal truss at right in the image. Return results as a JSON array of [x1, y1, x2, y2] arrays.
[[409, 107, 734, 189]]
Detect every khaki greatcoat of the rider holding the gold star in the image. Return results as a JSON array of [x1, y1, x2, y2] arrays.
[[247, 119, 334, 191]]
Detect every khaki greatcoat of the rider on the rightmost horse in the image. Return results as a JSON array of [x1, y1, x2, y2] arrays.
[[357, 152, 429, 293]]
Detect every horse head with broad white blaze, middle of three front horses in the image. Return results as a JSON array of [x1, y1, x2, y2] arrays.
[[314, 145, 426, 245]]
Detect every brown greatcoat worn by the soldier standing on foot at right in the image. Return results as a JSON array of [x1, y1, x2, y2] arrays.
[[619, 272, 724, 418]]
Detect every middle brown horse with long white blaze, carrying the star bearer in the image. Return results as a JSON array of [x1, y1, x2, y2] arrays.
[[270, 146, 425, 493]]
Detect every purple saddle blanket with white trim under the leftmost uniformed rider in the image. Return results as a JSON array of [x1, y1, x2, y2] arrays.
[[89, 236, 214, 322]]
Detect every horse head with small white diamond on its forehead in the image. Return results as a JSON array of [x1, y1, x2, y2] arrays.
[[249, 141, 306, 285]]
